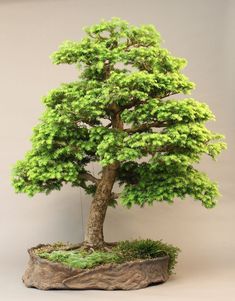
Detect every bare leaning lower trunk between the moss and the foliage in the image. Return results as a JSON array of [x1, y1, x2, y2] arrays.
[[85, 163, 118, 247]]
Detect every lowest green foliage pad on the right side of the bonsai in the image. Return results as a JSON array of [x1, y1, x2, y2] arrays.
[[121, 163, 219, 208]]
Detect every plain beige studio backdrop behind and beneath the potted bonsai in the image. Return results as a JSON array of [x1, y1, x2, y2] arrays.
[[0, 0, 235, 301]]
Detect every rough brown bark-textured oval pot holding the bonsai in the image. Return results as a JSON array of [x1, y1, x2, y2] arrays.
[[23, 247, 169, 290]]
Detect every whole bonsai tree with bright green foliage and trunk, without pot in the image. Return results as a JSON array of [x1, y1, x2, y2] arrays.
[[13, 18, 225, 248]]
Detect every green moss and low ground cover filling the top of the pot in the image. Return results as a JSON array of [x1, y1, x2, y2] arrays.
[[37, 239, 180, 274]]
